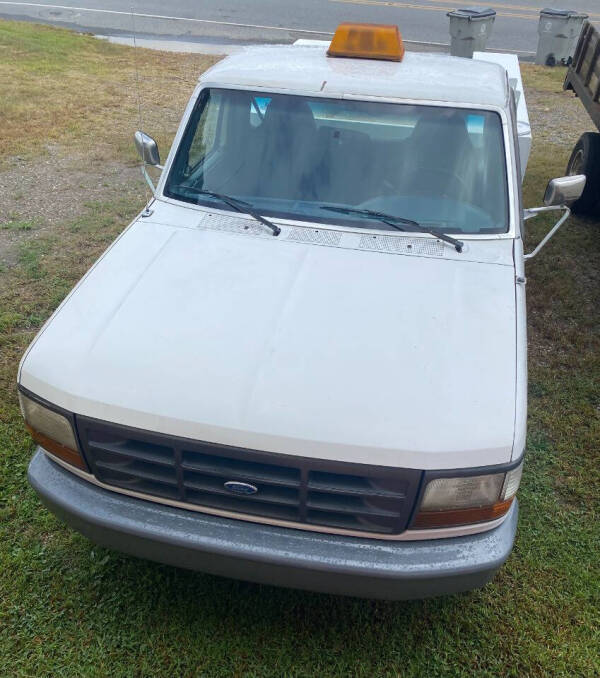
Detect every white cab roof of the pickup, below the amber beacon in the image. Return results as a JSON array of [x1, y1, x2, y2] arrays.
[[200, 43, 508, 108]]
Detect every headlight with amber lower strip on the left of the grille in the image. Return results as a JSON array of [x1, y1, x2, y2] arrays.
[[19, 391, 87, 470]]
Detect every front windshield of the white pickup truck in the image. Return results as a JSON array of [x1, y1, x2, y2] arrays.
[[165, 89, 508, 233]]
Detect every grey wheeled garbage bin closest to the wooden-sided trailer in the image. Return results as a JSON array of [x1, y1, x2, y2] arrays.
[[535, 8, 588, 66]]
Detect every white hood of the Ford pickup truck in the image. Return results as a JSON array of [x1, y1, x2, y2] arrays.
[[20, 209, 516, 469]]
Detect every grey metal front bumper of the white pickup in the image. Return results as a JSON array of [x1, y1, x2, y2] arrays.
[[29, 449, 518, 600]]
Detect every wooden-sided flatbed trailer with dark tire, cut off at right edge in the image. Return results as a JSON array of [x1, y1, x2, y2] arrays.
[[563, 21, 600, 216]]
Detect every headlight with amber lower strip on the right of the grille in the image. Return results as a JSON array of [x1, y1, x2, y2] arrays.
[[412, 462, 523, 529]]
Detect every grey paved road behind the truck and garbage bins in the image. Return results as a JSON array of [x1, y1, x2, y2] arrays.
[[0, 0, 600, 52]]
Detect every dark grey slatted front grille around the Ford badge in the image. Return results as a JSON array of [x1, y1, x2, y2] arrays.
[[77, 417, 422, 534]]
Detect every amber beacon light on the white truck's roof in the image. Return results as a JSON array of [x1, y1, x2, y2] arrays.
[[327, 23, 404, 61]]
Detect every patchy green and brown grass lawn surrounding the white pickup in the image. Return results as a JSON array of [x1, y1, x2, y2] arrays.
[[0, 21, 600, 677]]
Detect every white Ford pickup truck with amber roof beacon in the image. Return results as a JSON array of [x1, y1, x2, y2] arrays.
[[18, 25, 585, 599]]
